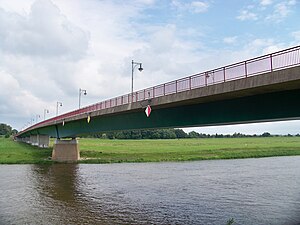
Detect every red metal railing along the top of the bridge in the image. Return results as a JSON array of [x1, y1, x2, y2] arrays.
[[22, 46, 300, 133]]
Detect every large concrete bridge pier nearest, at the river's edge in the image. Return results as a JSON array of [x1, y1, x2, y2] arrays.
[[52, 138, 80, 162]]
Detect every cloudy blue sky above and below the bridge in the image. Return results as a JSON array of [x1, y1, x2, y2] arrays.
[[0, 0, 300, 134]]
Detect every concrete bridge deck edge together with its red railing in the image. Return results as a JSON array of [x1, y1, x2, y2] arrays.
[[18, 46, 300, 135]]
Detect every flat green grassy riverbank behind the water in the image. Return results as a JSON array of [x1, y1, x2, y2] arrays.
[[0, 137, 300, 164]]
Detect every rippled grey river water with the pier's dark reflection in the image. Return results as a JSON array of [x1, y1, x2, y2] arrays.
[[0, 156, 300, 225]]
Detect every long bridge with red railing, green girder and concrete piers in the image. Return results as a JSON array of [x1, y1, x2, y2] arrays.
[[15, 46, 300, 161]]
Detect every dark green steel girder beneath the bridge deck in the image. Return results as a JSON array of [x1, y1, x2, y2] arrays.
[[26, 89, 300, 138]]
